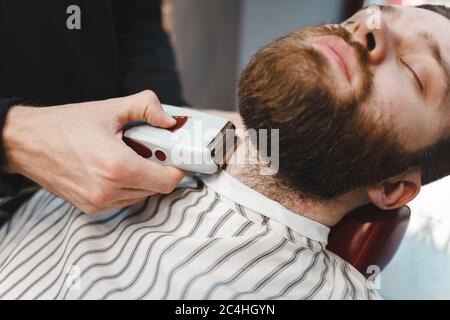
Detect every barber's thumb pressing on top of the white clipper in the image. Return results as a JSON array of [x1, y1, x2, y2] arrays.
[[119, 90, 176, 128]]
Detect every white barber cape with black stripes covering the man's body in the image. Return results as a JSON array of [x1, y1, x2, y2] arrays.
[[0, 173, 379, 299]]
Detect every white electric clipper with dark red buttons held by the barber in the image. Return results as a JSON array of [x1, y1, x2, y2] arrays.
[[123, 105, 237, 174]]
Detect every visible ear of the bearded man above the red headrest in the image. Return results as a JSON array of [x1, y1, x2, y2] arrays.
[[367, 170, 422, 210]]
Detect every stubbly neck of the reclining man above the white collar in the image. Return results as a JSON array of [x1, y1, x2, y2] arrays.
[[225, 137, 367, 227]]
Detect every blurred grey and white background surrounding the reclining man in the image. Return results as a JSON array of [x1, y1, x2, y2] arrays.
[[163, 0, 450, 299]]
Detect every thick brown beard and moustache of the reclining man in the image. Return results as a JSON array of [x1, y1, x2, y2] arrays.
[[238, 26, 450, 200]]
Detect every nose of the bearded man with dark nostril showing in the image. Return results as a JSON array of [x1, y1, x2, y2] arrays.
[[345, 18, 389, 65]]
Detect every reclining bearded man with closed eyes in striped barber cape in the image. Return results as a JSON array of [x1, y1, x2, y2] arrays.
[[0, 6, 450, 299]]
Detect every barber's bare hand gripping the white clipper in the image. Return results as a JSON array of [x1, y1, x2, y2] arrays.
[[3, 91, 184, 214]]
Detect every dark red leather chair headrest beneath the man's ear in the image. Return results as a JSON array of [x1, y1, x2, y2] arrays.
[[327, 205, 411, 277]]
